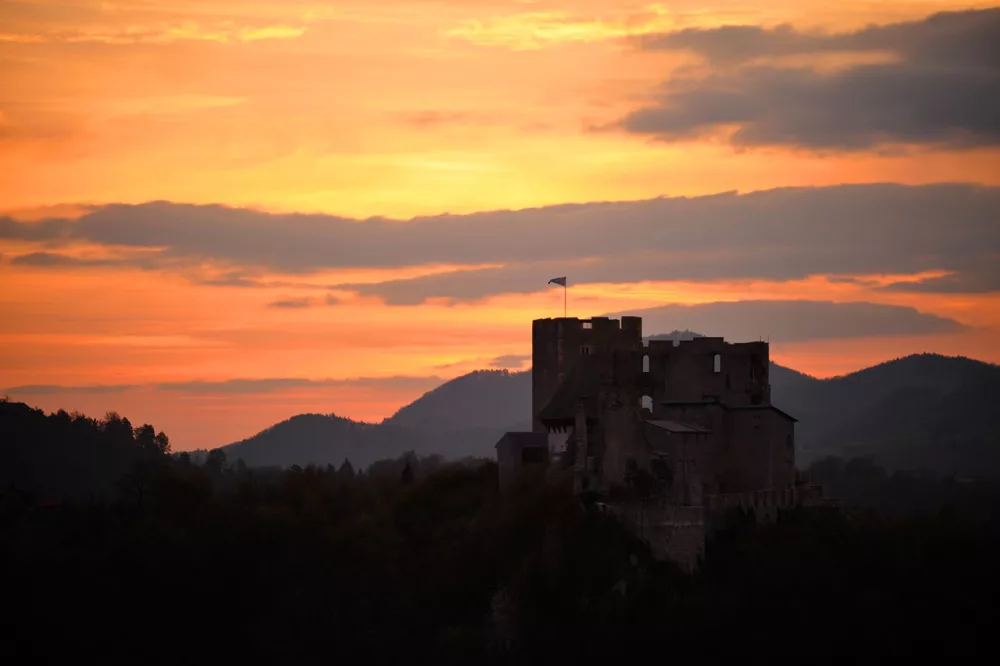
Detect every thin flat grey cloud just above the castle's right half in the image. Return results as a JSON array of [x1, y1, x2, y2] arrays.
[[608, 301, 965, 342]]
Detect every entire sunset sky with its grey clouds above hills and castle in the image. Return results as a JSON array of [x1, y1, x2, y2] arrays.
[[0, 0, 1000, 450]]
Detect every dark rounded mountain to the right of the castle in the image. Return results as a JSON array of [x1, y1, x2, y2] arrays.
[[771, 354, 1000, 474]]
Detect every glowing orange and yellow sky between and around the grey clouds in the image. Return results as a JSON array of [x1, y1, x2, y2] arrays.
[[0, 0, 1000, 449]]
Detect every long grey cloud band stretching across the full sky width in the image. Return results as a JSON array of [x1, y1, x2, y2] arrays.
[[0, 184, 1000, 304]]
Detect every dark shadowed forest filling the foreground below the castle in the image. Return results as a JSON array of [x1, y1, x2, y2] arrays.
[[0, 400, 1000, 664]]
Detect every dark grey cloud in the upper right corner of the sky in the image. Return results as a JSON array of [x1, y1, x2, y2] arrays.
[[617, 9, 1000, 150]]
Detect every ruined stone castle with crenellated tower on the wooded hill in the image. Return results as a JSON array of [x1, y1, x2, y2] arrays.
[[496, 317, 819, 569]]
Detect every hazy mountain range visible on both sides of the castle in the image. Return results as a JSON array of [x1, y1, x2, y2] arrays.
[[226, 352, 1000, 474]]
